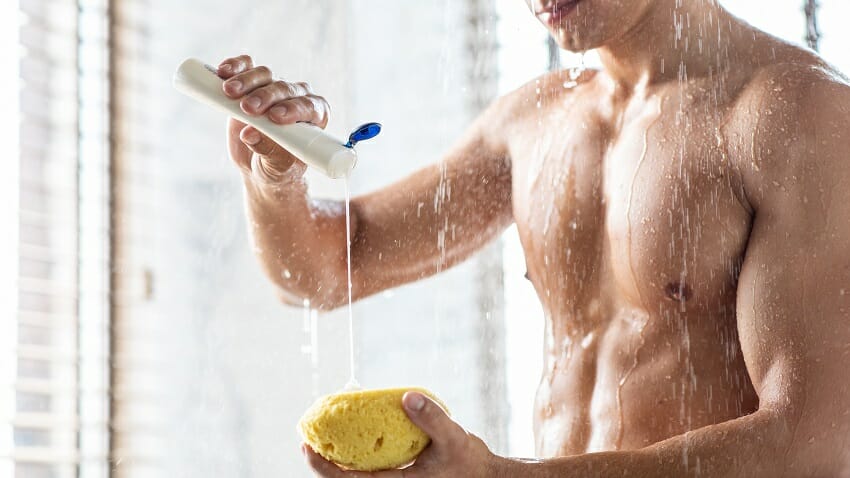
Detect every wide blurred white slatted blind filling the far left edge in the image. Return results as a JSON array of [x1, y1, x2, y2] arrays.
[[0, 0, 108, 478]]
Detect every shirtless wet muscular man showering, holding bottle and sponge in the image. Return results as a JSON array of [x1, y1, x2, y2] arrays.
[[219, 0, 850, 478]]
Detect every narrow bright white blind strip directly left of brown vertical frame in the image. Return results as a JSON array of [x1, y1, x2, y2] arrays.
[[77, 0, 114, 478]]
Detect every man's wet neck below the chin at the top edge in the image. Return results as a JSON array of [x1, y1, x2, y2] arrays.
[[598, 0, 741, 88]]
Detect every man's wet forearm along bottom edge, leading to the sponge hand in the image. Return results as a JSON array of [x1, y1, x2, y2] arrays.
[[496, 410, 806, 478]]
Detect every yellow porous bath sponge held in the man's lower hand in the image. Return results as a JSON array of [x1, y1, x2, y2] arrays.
[[298, 388, 446, 471]]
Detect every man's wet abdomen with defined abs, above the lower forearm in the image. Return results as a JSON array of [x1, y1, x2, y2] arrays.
[[535, 310, 757, 457]]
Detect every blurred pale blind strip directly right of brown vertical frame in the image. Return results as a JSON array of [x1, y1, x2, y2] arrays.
[[111, 0, 168, 472]]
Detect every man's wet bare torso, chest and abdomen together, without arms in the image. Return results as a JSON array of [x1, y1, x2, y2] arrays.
[[510, 61, 780, 457]]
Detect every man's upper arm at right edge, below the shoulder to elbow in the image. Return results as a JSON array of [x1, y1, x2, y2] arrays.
[[737, 197, 850, 459]]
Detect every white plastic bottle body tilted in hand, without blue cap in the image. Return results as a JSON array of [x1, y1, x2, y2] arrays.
[[174, 58, 357, 178]]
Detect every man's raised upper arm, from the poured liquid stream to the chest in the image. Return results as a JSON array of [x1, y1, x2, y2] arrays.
[[344, 115, 512, 297]]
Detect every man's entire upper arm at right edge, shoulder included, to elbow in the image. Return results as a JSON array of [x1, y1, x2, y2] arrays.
[[737, 78, 850, 464]]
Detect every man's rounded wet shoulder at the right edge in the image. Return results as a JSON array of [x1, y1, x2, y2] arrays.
[[727, 54, 850, 210]]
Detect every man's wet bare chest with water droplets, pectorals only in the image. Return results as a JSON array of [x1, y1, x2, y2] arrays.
[[512, 90, 750, 314]]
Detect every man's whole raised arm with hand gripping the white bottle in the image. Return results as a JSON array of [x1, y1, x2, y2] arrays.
[[219, 57, 512, 309]]
